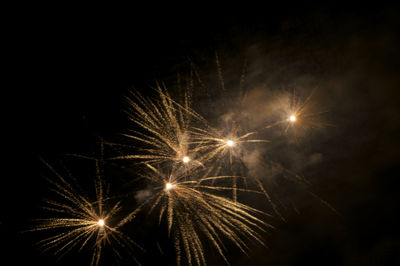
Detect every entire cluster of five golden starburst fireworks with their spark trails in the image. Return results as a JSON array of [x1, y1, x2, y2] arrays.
[[31, 57, 332, 265]]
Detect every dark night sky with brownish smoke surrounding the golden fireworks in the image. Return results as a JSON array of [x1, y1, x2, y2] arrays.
[[0, 4, 400, 266]]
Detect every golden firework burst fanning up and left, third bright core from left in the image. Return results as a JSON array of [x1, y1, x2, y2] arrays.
[[112, 87, 209, 170]]
